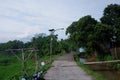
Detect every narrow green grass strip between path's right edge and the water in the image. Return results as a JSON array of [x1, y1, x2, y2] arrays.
[[74, 54, 107, 80]]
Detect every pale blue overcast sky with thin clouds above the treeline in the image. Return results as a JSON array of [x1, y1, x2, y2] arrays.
[[0, 0, 120, 43]]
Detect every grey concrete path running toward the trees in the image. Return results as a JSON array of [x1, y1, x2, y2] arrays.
[[45, 53, 95, 80]]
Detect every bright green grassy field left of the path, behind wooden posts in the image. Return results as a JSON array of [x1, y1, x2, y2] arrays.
[[0, 53, 64, 80]]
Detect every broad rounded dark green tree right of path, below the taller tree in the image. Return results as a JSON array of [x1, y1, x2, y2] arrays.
[[66, 15, 112, 57]]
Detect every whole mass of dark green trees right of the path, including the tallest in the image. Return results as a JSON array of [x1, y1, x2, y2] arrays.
[[66, 4, 120, 57]]
